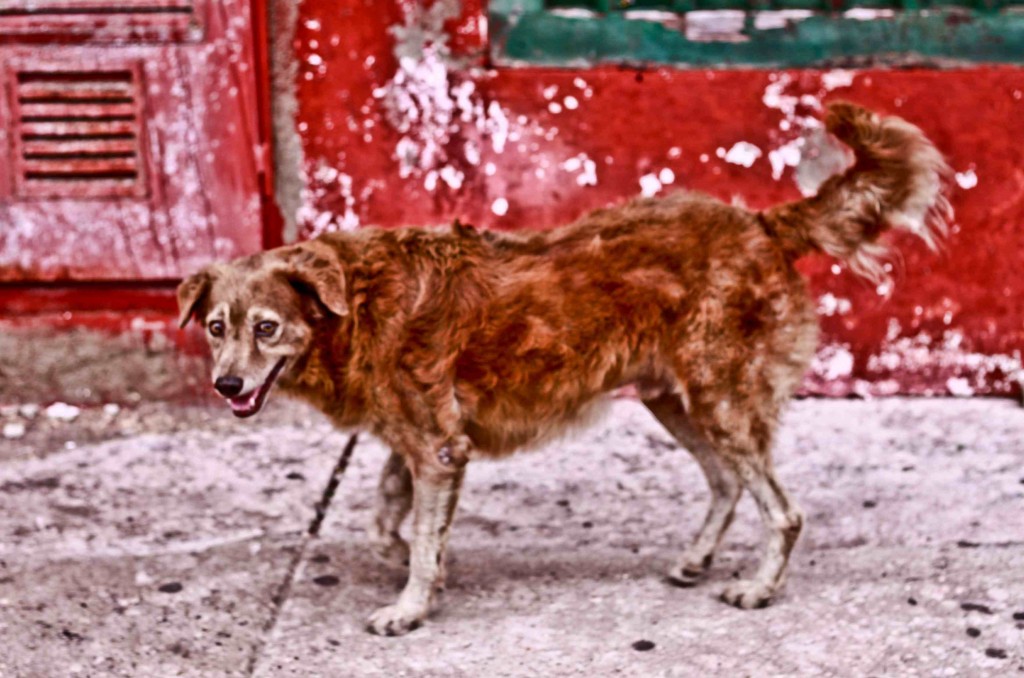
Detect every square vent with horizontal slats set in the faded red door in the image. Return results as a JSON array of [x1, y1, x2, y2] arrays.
[[13, 69, 146, 198]]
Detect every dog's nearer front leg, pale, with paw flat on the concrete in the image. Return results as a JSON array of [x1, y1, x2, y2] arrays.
[[368, 462, 464, 636]]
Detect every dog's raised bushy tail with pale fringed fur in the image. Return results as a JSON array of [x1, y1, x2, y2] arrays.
[[761, 102, 952, 284]]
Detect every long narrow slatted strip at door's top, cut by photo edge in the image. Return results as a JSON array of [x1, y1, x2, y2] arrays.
[[0, 0, 199, 42]]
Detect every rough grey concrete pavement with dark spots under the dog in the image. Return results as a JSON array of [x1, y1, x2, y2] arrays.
[[0, 399, 1024, 678]]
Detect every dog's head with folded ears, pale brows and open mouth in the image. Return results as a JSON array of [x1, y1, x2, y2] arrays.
[[178, 241, 348, 417]]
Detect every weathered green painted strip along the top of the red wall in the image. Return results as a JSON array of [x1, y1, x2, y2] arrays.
[[490, 0, 1024, 67]]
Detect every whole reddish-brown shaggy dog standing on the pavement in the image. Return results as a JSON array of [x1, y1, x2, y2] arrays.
[[177, 103, 951, 635]]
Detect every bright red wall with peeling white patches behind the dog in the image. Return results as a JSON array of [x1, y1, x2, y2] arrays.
[[278, 0, 1024, 395]]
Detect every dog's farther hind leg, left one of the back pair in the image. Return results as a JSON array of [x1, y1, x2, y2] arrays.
[[644, 394, 742, 587]]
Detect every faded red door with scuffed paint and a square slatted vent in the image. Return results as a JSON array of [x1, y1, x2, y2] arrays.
[[0, 0, 267, 281]]
